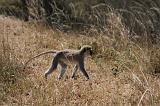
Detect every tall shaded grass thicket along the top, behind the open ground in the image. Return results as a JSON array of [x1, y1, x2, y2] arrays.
[[13, 0, 160, 40]]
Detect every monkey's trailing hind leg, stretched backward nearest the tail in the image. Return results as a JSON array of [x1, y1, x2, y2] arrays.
[[44, 57, 58, 79]]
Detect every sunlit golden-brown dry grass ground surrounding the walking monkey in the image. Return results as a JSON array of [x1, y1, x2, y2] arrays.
[[0, 14, 160, 106]]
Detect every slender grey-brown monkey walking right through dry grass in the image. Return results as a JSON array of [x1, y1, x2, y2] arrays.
[[26, 45, 93, 80]]
